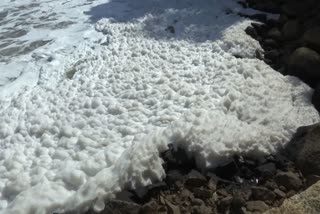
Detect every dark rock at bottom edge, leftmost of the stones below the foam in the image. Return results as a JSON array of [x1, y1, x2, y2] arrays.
[[103, 200, 141, 214]]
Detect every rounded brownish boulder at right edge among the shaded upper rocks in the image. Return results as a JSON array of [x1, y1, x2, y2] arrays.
[[288, 47, 320, 80]]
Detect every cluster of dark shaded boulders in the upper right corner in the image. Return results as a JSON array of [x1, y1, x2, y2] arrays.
[[243, 0, 320, 111]]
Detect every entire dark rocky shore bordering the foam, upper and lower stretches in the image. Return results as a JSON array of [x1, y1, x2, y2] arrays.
[[82, 0, 320, 214]]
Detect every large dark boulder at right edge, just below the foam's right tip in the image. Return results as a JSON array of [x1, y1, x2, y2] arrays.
[[285, 123, 320, 175]]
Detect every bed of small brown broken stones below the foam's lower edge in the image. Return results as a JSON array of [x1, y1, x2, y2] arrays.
[[87, 146, 306, 214]]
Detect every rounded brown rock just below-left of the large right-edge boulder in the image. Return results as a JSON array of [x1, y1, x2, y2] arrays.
[[274, 172, 302, 190]]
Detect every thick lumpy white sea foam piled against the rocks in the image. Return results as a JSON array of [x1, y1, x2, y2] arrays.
[[0, 0, 319, 214]]
